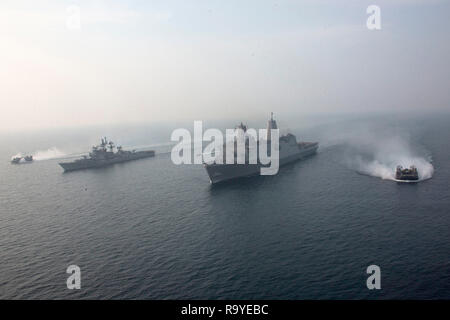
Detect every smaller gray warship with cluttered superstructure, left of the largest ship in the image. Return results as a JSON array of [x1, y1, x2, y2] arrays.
[[59, 138, 155, 171]]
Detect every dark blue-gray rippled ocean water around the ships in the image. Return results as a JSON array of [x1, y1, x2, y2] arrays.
[[0, 116, 450, 299]]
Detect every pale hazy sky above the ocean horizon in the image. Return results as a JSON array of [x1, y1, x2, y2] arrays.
[[0, 0, 450, 130]]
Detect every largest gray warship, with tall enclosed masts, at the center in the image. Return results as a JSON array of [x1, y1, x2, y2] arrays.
[[203, 113, 319, 184]]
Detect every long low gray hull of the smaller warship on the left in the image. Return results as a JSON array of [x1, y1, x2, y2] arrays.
[[59, 150, 155, 172]]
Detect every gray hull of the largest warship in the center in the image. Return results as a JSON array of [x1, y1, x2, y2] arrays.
[[204, 142, 319, 184]]
